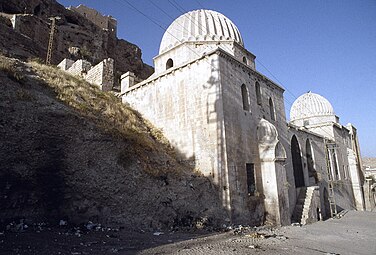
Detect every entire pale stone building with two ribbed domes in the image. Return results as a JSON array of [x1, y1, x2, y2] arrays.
[[121, 10, 363, 225]]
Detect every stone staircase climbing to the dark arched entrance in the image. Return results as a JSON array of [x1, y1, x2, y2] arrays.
[[291, 186, 319, 225]]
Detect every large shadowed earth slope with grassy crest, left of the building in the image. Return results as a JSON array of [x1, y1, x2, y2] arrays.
[[0, 56, 226, 229]]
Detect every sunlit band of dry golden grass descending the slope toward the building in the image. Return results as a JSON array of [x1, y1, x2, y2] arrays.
[[29, 62, 180, 175]]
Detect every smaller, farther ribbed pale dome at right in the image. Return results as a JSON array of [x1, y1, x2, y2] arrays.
[[290, 91, 335, 121]]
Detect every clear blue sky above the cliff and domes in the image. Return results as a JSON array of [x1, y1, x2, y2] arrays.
[[58, 0, 376, 157]]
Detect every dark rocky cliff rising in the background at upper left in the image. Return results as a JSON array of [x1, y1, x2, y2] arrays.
[[0, 0, 153, 79]]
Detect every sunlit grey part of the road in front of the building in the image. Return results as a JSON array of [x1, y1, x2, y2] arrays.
[[138, 211, 376, 255]]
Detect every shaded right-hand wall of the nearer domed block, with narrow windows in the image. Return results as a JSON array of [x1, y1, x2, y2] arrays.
[[220, 49, 289, 224]]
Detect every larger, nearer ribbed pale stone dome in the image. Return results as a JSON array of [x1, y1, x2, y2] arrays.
[[159, 10, 244, 54]]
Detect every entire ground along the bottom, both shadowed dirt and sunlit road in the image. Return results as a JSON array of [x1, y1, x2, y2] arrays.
[[0, 211, 376, 255]]
